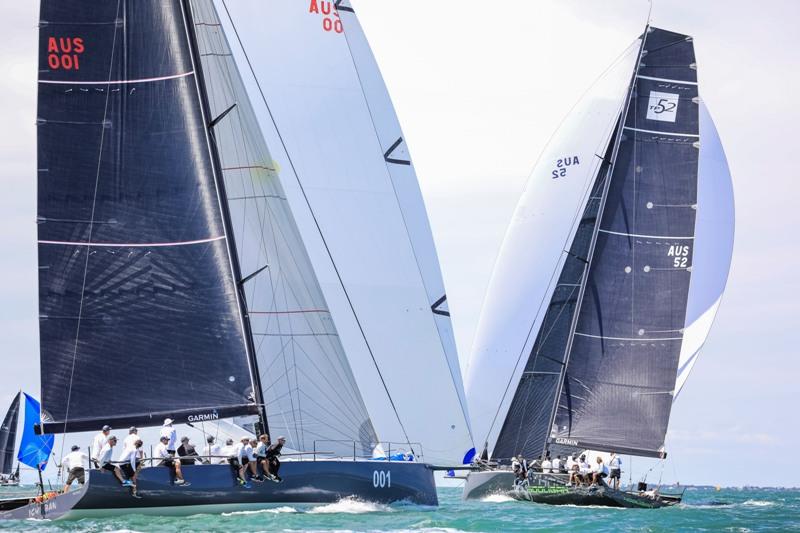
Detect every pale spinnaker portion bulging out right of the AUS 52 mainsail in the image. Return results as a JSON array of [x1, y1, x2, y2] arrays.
[[674, 101, 736, 398]]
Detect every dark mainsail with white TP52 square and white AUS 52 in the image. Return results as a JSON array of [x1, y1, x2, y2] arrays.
[[553, 28, 700, 457]]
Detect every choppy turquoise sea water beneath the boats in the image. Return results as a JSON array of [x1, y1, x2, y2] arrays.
[[0, 488, 800, 533]]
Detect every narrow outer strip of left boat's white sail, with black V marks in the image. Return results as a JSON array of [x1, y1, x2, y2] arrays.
[[330, 0, 469, 444]]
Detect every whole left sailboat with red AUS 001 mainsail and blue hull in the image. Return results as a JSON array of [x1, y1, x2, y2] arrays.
[[0, 0, 471, 519]]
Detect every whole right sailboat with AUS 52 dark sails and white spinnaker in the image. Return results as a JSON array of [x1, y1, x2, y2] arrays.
[[464, 26, 733, 507]]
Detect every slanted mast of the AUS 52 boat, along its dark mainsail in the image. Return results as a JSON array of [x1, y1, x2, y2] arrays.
[[542, 23, 650, 455]]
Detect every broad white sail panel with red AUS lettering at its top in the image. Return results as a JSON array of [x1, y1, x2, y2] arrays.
[[216, 0, 472, 463]]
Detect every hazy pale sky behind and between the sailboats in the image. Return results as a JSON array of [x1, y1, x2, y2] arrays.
[[0, 0, 800, 485]]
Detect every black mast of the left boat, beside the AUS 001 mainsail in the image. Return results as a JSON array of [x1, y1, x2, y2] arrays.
[[180, 0, 269, 434]]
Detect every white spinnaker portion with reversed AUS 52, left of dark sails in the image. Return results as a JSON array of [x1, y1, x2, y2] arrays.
[[466, 41, 639, 458]]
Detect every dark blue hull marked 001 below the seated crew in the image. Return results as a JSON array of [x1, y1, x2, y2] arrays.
[[0, 461, 438, 519]]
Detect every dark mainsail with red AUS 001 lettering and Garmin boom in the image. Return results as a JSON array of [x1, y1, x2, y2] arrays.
[[38, 0, 257, 432]]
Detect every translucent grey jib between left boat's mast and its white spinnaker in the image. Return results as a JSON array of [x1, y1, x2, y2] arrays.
[[190, 0, 378, 456]]
